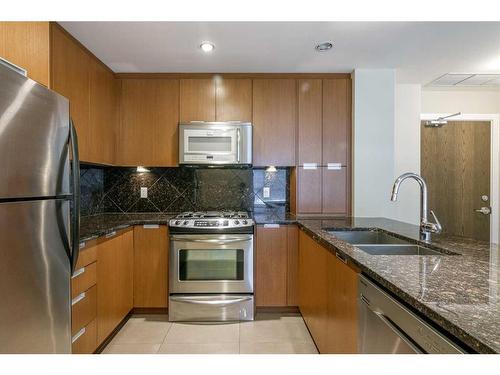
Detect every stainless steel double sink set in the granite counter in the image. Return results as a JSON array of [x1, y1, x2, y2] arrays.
[[325, 229, 458, 255]]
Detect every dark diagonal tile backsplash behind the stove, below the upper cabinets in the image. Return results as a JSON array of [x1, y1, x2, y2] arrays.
[[80, 165, 290, 216]]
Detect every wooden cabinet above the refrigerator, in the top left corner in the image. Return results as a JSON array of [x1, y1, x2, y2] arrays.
[[0, 22, 50, 87]]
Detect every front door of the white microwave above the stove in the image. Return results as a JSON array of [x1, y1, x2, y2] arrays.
[[182, 126, 239, 164]]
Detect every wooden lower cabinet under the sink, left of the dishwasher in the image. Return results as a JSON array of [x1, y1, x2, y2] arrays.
[[299, 231, 358, 354]]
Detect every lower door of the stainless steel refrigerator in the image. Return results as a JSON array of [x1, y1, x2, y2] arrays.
[[0, 200, 71, 353]]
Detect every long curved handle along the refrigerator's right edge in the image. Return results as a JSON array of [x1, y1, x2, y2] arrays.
[[69, 119, 80, 273]]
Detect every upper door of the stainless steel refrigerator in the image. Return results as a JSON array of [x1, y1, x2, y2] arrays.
[[0, 65, 70, 199]]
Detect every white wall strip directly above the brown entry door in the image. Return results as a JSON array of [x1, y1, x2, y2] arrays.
[[422, 90, 500, 114]]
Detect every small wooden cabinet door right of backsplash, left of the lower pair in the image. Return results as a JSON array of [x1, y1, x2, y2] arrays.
[[297, 167, 323, 214]]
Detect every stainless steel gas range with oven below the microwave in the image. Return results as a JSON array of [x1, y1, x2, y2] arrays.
[[169, 211, 254, 321]]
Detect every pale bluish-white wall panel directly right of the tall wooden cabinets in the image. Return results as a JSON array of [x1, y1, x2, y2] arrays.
[[353, 69, 395, 217]]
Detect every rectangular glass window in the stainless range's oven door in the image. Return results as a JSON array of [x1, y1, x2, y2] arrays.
[[179, 249, 244, 281]]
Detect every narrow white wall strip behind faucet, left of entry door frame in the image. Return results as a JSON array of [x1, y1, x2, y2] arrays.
[[392, 84, 422, 224]]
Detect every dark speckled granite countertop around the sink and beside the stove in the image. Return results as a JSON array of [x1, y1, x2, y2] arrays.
[[80, 213, 500, 353]]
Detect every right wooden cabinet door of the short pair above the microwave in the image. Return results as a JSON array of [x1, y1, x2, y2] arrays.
[[215, 78, 252, 122]]
